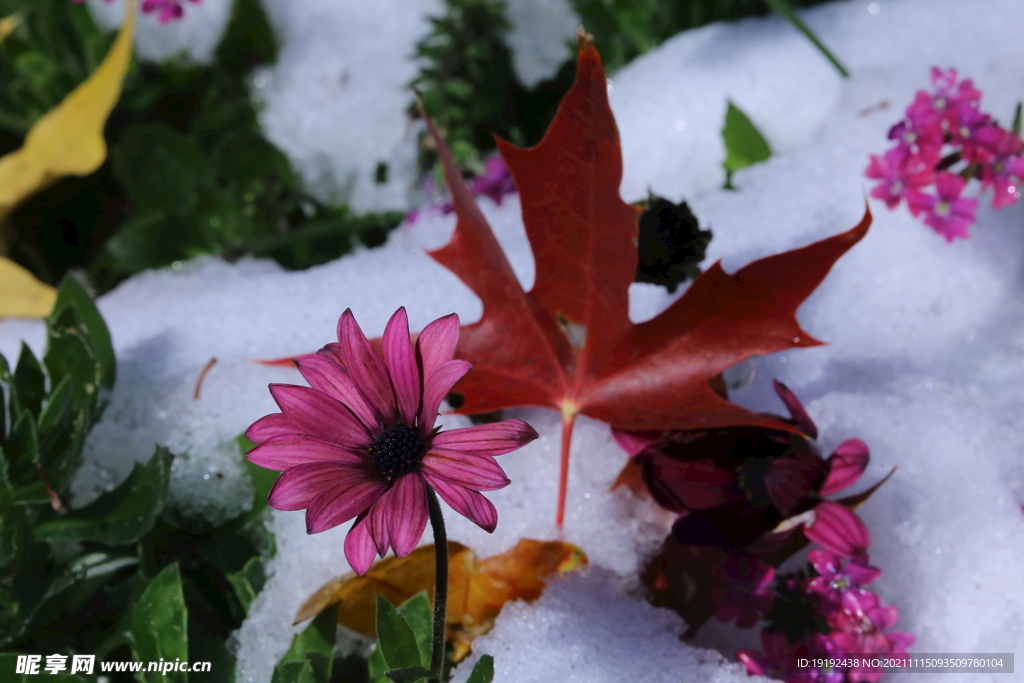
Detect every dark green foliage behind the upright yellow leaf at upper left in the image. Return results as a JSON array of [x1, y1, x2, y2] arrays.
[[0, 0, 401, 291]]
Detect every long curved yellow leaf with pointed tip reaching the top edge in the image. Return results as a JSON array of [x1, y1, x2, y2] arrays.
[[0, 0, 135, 219]]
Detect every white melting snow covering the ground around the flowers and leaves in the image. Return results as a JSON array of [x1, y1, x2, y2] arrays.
[[0, 0, 1024, 683]]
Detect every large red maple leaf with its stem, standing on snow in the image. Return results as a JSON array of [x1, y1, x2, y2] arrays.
[[419, 38, 870, 527]]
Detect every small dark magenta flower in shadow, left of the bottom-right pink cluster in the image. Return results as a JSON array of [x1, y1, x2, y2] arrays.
[[711, 554, 775, 629]]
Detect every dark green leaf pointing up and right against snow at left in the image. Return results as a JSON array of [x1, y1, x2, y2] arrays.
[[34, 446, 173, 546]]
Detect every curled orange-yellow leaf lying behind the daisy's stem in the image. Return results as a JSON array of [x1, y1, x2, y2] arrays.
[[295, 539, 587, 661]]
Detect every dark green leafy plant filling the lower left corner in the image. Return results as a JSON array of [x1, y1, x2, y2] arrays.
[[0, 284, 276, 683]]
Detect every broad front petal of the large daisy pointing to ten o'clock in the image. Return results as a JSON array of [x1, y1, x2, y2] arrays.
[[270, 384, 373, 447]]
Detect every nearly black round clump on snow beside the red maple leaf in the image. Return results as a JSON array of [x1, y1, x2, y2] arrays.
[[635, 195, 712, 293]]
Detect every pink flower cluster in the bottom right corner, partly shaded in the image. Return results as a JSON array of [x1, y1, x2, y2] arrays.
[[736, 549, 914, 683]]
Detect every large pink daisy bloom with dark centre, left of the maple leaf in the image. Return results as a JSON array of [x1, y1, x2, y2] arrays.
[[246, 308, 538, 574]]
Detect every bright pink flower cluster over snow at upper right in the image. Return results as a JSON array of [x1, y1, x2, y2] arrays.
[[865, 68, 1024, 242]]
